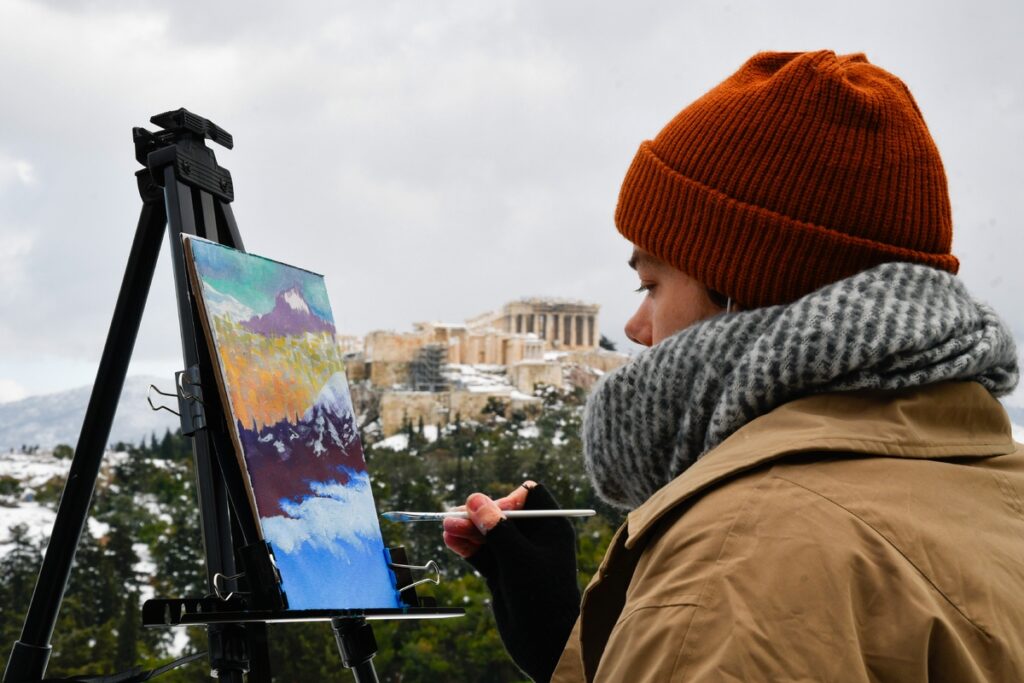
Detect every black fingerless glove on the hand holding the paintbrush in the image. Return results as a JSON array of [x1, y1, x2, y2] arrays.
[[468, 484, 580, 681]]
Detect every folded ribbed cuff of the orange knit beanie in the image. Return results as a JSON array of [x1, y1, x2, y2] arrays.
[[615, 141, 959, 308]]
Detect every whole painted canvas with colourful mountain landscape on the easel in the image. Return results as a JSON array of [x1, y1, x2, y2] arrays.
[[185, 238, 399, 609]]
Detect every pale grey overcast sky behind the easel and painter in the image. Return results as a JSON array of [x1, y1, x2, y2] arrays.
[[0, 0, 1024, 401]]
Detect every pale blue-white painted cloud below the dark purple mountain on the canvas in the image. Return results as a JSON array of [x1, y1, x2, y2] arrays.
[[260, 470, 380, 557]]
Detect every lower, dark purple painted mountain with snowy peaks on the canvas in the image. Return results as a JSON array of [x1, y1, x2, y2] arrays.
[[238, 373, 367, 517]]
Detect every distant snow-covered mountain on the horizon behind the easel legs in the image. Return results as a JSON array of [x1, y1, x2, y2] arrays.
[[0, 376, 181, 453]]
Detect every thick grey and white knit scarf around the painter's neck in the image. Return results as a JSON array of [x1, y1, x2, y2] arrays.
[[584, 263, 1018, 508]]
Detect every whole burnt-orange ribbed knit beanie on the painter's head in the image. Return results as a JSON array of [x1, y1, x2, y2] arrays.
[[615, 50, 959, 308]]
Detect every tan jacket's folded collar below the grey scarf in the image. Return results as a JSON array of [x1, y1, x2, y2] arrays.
[[626, 382, 1016, 548]]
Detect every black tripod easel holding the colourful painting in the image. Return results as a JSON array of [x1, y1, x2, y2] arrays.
[[3, 109, 463, 683]]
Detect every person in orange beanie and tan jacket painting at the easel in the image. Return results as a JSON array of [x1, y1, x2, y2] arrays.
[[444, 51, 1024, 682]]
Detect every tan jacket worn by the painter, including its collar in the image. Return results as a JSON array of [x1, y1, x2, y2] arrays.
[[552, 382, 1024, 683]]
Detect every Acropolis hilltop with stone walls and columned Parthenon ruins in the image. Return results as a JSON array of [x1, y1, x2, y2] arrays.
[[338, 298, 629, 436]]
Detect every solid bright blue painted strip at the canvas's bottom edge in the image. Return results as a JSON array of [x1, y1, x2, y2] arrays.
[[273, 542, 401, 609]]
